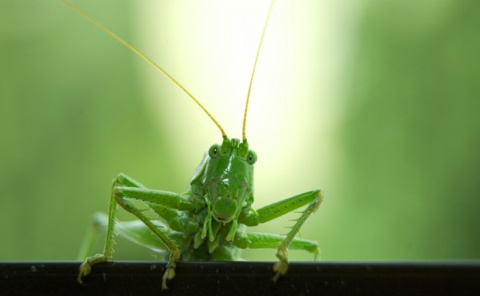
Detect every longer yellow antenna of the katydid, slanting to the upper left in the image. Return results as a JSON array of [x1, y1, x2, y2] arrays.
[[60, 0, 227, 138]]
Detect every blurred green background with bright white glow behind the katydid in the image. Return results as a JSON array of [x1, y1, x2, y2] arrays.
[[0, 0, 480, 261]]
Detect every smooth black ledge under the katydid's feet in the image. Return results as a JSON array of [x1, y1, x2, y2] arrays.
[[0, 261, 480, 296]]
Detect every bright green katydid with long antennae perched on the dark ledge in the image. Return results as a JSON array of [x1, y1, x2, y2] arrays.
[[60, 0, 323, 289]]
